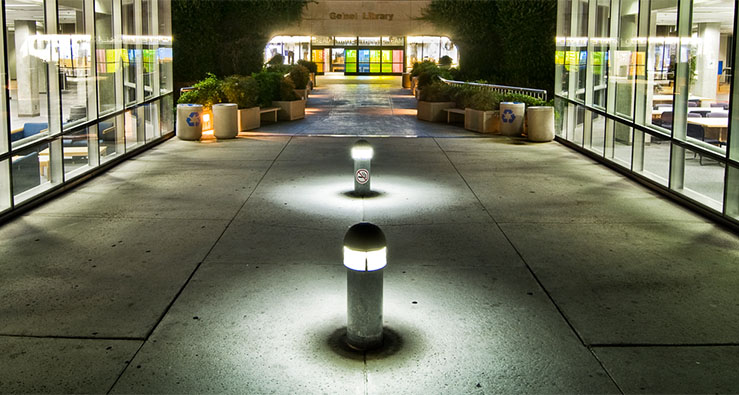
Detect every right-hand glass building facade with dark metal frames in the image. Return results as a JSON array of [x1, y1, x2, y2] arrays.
[[554, 0, 739, 224]]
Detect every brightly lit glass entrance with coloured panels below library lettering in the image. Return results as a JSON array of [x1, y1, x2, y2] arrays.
[[264, 36, 458, 75]]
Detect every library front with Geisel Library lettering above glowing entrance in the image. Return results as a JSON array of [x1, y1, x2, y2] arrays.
[[265, 0, 457, 75]]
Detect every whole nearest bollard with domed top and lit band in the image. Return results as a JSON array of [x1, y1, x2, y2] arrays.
[[344, 222, 387, 350]]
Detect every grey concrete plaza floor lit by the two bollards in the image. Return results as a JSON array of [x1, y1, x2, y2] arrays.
[[0, 76, 739, 394]]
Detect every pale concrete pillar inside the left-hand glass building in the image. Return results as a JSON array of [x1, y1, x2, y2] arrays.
[[14, 20, 41, 117]]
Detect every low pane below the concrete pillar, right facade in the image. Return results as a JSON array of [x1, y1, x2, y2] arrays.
[[678, 145, 725, 211]]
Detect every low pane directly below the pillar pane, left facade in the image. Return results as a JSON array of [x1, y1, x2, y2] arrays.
[[10, 143, 51, 203]]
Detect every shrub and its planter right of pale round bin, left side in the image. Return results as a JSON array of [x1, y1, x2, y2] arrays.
[[221, 75, 260, 132]]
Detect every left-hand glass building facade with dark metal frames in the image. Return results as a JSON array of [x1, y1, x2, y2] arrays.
[[0, 0, 174, 215]]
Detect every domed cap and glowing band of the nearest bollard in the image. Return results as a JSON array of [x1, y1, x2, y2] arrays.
[[344, 222, 387, 272]]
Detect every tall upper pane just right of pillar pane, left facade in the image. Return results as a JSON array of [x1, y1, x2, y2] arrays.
[[56, 0, 97, 129]]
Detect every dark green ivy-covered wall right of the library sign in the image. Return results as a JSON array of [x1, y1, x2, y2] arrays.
[[422, 0, 557, 95]]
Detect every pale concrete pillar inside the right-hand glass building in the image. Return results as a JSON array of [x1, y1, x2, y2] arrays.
[[690, 23, 721, 99]]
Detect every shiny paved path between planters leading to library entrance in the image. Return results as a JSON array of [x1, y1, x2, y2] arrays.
[[256, 75, 482, 137]]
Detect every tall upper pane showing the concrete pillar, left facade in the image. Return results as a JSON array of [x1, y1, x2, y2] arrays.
[[3, 2, 51, 147]]
